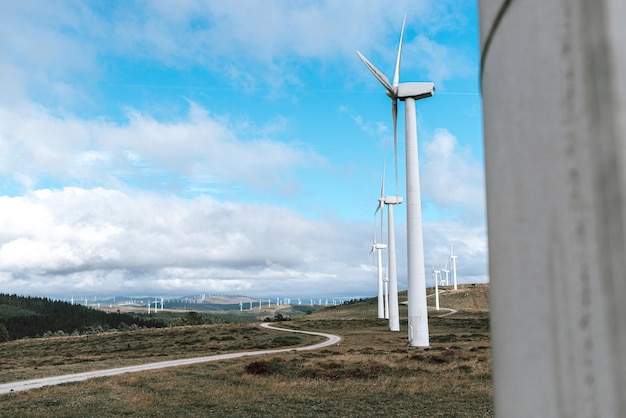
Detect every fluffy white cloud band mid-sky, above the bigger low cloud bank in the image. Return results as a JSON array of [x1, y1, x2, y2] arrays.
[[0, 103, 325, 198]]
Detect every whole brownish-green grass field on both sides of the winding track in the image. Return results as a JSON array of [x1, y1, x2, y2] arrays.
[[0, 285, 493, 417]]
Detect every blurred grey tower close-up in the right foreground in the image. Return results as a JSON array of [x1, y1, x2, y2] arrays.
[[480, 0, 626, 418]]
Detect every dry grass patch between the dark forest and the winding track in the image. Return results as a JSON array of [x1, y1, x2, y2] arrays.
[[0, 324, 321, 383]]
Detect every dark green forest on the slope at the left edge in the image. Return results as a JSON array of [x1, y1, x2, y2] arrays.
[[0, 293, 166, 342]]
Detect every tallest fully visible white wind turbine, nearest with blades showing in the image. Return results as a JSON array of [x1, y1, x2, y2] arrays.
[[357, 16, 435, 347]]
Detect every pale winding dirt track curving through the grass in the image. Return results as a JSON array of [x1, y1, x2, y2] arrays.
[[0, 323, 341, 395]]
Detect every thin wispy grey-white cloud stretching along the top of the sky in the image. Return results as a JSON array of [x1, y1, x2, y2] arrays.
[[0, 0, 470, 107]]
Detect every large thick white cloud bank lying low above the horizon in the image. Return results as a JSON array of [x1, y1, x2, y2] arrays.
[[0, 188, 371, 296]]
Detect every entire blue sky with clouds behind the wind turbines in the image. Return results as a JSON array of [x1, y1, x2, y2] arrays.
[[0, 0, 489, 300]]
